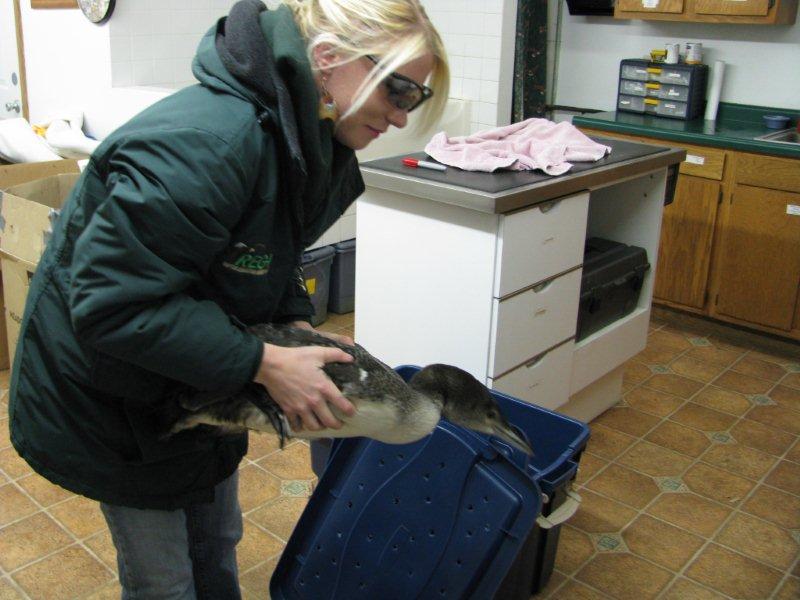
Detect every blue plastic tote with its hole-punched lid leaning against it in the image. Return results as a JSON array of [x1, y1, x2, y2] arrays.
[[270, 366, 589, 600]]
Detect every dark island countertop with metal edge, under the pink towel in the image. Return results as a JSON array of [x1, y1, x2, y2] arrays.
[[361, 137, 686, 213]]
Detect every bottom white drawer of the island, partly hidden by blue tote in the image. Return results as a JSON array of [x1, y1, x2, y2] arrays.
[[489, 340, 575, 410]]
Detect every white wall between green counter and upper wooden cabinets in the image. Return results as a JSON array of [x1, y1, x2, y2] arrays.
[[548, 0, 800, 110]]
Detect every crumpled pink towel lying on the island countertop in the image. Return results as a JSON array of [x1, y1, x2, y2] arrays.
[[425, 119, 611, 175]]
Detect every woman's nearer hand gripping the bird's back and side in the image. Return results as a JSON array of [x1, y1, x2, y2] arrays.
[[255, 344, 355, 431]]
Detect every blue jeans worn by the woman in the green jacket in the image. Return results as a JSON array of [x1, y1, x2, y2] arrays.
[[100, 471, 242, 600]]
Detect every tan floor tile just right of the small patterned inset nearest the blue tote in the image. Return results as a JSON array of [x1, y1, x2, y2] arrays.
[[622, 515, 705, 571]]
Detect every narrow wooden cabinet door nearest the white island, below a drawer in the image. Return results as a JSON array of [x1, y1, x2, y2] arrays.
[[653, 175, 720, 308]]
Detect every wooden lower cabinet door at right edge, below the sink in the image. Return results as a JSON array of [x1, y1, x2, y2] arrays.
[[716, 184, 800, 331]]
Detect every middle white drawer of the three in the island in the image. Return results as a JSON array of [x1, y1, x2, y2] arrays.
[[489, 269, 581, 377]]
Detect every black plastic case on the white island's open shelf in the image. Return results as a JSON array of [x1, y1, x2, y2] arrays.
[[576, 238, 650, 341]]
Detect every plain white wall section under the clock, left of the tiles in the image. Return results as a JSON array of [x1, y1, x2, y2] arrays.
[[20, 2, 111, 123]]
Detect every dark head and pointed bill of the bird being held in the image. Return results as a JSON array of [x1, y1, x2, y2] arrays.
[[409, 364, 533, 456]]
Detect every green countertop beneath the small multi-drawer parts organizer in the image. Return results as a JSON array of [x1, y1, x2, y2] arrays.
[[572, 102, 800, 159]]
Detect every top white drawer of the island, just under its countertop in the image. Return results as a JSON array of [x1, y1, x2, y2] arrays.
[[494, 192, 589, 298]]
